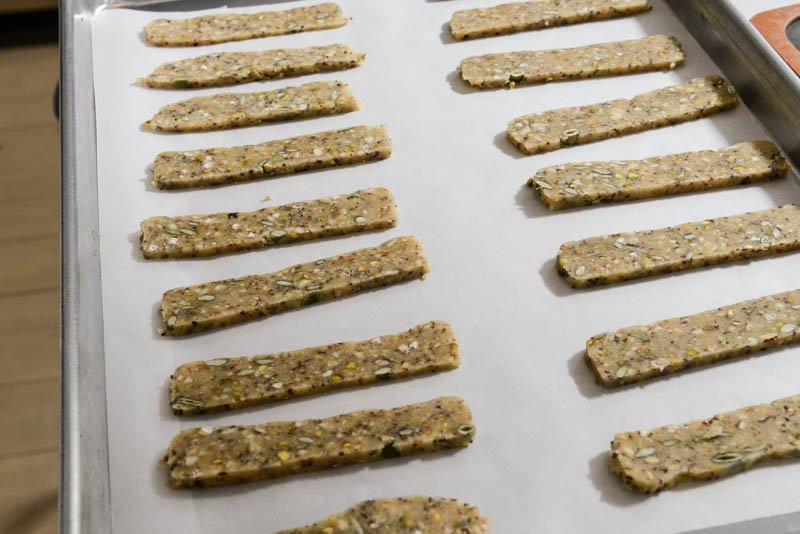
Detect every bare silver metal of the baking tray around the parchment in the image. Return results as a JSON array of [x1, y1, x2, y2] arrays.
[[61, 0, 800, 532]]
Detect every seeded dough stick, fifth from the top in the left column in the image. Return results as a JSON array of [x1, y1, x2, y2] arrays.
[[140, 187, 397, 259]]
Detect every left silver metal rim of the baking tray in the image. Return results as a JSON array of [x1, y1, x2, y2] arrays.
[[59, 0, 111, 534]]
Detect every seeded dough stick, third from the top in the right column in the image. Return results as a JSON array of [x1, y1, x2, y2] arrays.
[[507, 75, 739, 154]]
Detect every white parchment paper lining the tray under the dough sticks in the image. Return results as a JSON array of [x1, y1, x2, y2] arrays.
[[93, 0, 800, 534]]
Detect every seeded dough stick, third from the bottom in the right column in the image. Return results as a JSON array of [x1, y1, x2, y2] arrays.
[[556, 204, 800, 288]]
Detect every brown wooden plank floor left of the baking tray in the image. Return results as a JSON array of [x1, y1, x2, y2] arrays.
[[0, 42, 60, 534]]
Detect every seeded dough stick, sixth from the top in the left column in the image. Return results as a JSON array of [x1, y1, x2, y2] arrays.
[[160, 236, 428, 336]]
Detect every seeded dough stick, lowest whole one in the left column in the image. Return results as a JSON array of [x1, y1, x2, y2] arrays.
[[164, 397, 475, 489]]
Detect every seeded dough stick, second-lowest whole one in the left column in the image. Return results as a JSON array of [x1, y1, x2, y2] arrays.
[[169, 321, 460, 415]]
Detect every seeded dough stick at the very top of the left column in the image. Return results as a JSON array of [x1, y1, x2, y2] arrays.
[[144, 2, 347, 46]]
